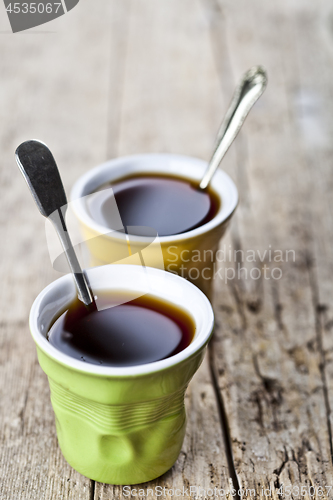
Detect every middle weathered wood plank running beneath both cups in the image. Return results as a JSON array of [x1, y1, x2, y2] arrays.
[[95, 0, 229, 500]]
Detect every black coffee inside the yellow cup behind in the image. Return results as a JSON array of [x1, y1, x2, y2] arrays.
[[90, 174, 219, 236]]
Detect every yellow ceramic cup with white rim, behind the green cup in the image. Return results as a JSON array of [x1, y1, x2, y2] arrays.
[[71, 154, 238, 298]]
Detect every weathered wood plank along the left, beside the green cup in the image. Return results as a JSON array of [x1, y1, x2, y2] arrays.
[[0, 0, 127, 500]]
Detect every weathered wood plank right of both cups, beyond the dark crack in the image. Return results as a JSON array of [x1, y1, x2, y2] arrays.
[[205, 0, 333, 498]]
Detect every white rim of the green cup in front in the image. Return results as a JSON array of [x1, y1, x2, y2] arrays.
[[29, 264, 214, 377]]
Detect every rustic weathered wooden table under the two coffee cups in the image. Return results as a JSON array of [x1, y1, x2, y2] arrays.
[[0, 0, 333, 500]]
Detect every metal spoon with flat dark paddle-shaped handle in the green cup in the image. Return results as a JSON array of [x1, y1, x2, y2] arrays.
[[15, 141, 96, 310]]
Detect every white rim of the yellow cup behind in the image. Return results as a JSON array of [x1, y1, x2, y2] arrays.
[[70, 153, 238, 244]]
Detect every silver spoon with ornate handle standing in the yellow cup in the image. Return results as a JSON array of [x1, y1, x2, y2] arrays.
[[199, 66, 267, 189]]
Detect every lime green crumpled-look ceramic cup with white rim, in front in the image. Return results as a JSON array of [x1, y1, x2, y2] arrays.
[[30, 265, 214, 484]]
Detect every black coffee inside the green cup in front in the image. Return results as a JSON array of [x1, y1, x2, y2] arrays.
[[48, 294, 195, 366]]
